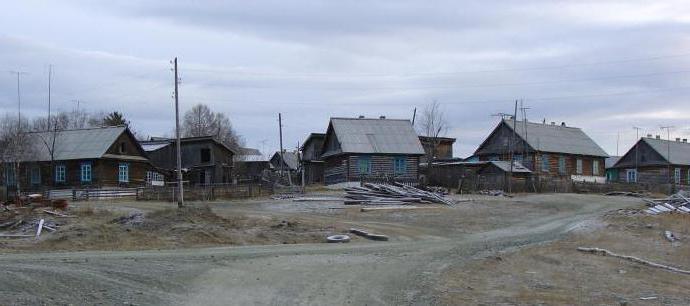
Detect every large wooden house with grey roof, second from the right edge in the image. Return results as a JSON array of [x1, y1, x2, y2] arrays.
[[474, 119, 608, 182]]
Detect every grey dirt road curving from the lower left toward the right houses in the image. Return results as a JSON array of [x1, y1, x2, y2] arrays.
[[0, 195, 640, 305]]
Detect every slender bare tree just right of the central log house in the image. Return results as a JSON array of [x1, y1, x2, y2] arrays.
[[418, 100, 448, 178]]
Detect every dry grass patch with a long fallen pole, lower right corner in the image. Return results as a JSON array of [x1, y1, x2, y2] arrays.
[[442, 214, 690, 305]]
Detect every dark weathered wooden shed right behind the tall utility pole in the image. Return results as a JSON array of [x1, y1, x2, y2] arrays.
[[141, 136, 235, 185]]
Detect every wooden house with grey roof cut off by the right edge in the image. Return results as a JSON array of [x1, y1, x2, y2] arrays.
[[611, 135, 690, 185]]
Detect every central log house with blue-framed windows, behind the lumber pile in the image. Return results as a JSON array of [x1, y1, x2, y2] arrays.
[[321, 117, 424, 184]]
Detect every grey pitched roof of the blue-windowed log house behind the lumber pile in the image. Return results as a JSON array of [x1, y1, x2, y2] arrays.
[[324, 118, 424, 156]]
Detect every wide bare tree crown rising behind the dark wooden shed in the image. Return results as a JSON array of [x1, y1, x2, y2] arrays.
[[182, 104, 244, 150]]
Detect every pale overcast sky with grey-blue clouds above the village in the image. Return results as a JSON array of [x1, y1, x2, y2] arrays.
[[0, 0, 690, 157]]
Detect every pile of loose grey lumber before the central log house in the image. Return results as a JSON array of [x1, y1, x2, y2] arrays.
[[345, 183, 455, 205]]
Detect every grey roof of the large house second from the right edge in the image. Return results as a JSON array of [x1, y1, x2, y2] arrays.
[[503, 119, 609, 157]]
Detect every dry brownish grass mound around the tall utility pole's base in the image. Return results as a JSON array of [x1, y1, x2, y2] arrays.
[[4, 205, 346, 252]]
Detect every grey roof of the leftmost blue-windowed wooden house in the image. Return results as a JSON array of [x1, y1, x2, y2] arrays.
[[29, 126, 127, 161]]
